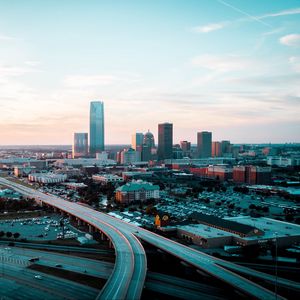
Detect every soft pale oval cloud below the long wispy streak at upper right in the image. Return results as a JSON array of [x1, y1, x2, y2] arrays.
[[192, 54, 251, 72]]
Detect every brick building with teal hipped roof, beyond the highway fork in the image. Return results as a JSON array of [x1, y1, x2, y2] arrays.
[[116, 180, 159, 203]]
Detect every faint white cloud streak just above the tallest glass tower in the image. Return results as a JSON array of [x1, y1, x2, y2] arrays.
[[64, 75, 117, 87]]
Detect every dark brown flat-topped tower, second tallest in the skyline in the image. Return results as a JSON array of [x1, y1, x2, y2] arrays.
[[158, 123, 173, 160]]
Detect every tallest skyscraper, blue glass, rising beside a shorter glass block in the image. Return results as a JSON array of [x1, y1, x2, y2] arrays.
[[90, 101, 104, 156]]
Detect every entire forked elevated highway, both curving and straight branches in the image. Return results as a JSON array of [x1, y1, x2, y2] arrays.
[[0, 178, 296, 299]]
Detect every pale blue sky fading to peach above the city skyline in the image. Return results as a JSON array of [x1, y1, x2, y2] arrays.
[[0, 0, 300, 145]]
